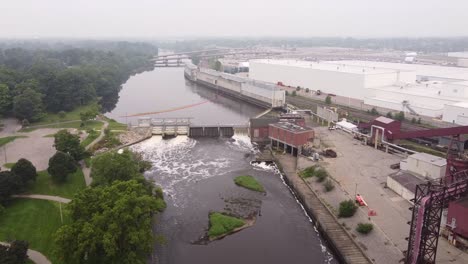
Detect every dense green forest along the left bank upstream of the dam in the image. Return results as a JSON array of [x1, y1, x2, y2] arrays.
[[0, 42, 157, 122]]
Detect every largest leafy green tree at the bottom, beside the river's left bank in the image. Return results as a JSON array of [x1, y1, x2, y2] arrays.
[[55, 180, 165, 264]]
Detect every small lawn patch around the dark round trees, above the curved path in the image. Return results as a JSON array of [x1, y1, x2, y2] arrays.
[[27, 169, 86, 198]]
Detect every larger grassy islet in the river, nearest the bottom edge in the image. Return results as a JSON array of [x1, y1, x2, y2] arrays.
[[208, 212, 255, 241]]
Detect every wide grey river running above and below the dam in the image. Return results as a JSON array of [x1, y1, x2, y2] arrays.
[[108, 68, 336, 264]]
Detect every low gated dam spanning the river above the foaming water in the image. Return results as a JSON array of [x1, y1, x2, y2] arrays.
[[138, 117, 249, 138]]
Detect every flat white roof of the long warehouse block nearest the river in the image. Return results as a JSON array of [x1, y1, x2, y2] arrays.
[[250, 59, 397, 75]]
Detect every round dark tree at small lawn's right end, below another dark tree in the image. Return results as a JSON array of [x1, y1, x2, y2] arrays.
[[47, 151, 76, 183]]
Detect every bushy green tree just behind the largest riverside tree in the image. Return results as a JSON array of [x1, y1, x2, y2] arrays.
[[91, 150, 141, 185]]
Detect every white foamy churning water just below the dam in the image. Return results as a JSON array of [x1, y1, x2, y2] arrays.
[[132, 136, 252, 207]]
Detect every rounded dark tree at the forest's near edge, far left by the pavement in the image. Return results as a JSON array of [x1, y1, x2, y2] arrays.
[[13, 88, 44, 121]]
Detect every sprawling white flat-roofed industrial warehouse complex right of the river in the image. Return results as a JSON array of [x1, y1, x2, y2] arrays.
[[249, 59, 468, 125]]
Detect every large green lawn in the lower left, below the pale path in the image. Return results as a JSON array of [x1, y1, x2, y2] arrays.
[[0, 199, 70, 264]]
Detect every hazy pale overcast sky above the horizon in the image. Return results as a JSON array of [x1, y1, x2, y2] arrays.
[[0, 0, 468, 38]]
